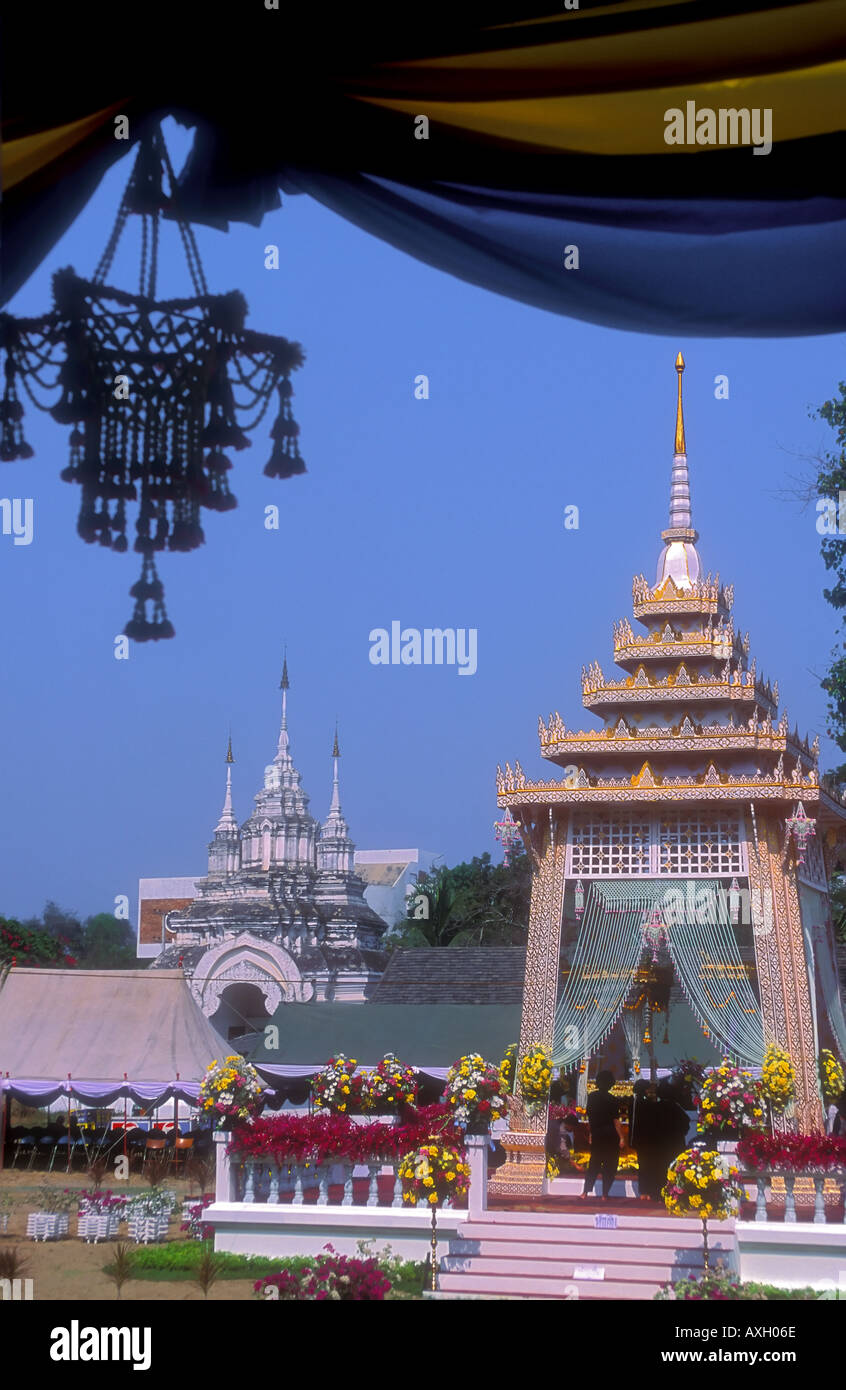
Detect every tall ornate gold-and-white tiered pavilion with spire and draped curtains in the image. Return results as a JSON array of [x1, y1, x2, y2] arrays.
[[495, 353, 846, 1193]]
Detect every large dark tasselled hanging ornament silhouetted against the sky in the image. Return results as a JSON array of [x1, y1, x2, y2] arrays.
[[0, 126, 306, 642]]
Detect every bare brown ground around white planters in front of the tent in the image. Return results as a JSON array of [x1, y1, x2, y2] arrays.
[[0, 1169, 253, 1302]]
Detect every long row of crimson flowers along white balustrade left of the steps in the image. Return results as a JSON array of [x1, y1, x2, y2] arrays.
[[229, 1105, 461, 1165]]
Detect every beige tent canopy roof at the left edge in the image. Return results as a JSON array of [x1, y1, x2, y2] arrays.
[[0, 969, 231, 1083]]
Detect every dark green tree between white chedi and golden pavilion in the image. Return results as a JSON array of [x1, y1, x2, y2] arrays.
[[385, 853, 532, 948]]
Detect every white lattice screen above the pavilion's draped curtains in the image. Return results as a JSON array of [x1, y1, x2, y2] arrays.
[[565, 810, 746, 878]]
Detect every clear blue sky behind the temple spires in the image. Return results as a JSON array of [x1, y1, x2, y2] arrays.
[[0, 122, 843, 916]]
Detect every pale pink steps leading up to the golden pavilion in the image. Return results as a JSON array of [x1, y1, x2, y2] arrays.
[[439, 1211, 735, 1300]]
